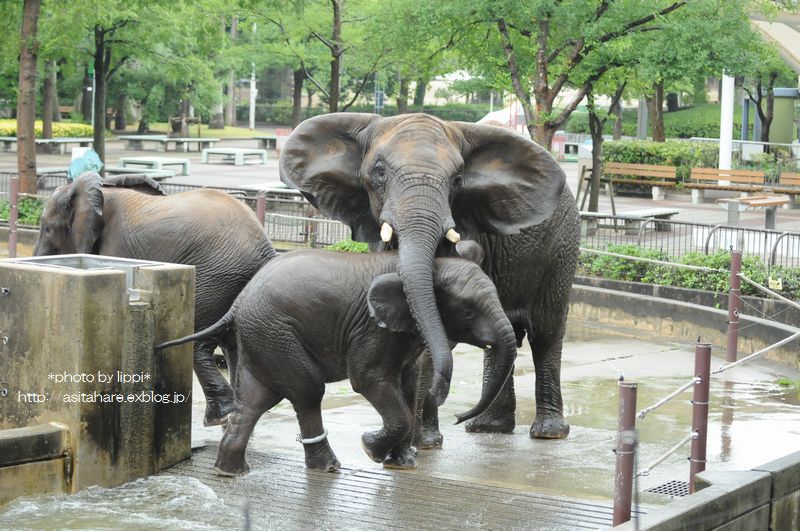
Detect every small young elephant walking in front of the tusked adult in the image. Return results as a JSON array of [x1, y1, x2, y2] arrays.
[[158, 250, 516, 475]]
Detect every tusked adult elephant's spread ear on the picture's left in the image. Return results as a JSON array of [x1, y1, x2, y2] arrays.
[[279, 113, 380, 242]]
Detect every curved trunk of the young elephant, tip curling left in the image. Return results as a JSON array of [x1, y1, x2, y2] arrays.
[[456, 310, 517, 424]]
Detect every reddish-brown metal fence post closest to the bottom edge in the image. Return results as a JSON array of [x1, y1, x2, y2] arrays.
[[614, 382, 637, 525]]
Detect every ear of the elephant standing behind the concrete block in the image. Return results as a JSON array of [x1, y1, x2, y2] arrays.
[[69, 173, 105, 253]]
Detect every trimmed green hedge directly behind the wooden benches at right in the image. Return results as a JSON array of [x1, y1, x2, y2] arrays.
[[603, 140, 719, 182]]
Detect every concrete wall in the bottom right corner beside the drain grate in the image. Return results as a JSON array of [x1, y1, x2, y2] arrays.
[[614, 452, 800, 531]]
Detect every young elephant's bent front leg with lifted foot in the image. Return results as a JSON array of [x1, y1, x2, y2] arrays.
[[360, 378, 416, 463]]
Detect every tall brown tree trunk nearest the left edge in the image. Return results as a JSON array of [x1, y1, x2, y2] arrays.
[[17, 0, 42, 194]]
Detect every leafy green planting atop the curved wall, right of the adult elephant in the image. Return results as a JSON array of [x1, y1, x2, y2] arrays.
[[578, 245, 800, 300]]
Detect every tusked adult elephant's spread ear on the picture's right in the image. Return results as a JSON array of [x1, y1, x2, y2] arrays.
[[452, 122, 566, 234]]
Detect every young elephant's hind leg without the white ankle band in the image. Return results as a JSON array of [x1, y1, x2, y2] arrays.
[[214, 368, 283, 476]]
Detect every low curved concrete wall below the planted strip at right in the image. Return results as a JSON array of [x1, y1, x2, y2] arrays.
[[570, 285, 800, 368]]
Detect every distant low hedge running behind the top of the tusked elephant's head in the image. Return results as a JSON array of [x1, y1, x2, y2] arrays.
[[236, 102, 489, 125]]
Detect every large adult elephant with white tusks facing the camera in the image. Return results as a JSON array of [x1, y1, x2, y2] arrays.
[[280, 113, 579, 447]]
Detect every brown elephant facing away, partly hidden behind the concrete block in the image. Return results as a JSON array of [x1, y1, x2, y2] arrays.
[[34, 174, 275, 426]]
